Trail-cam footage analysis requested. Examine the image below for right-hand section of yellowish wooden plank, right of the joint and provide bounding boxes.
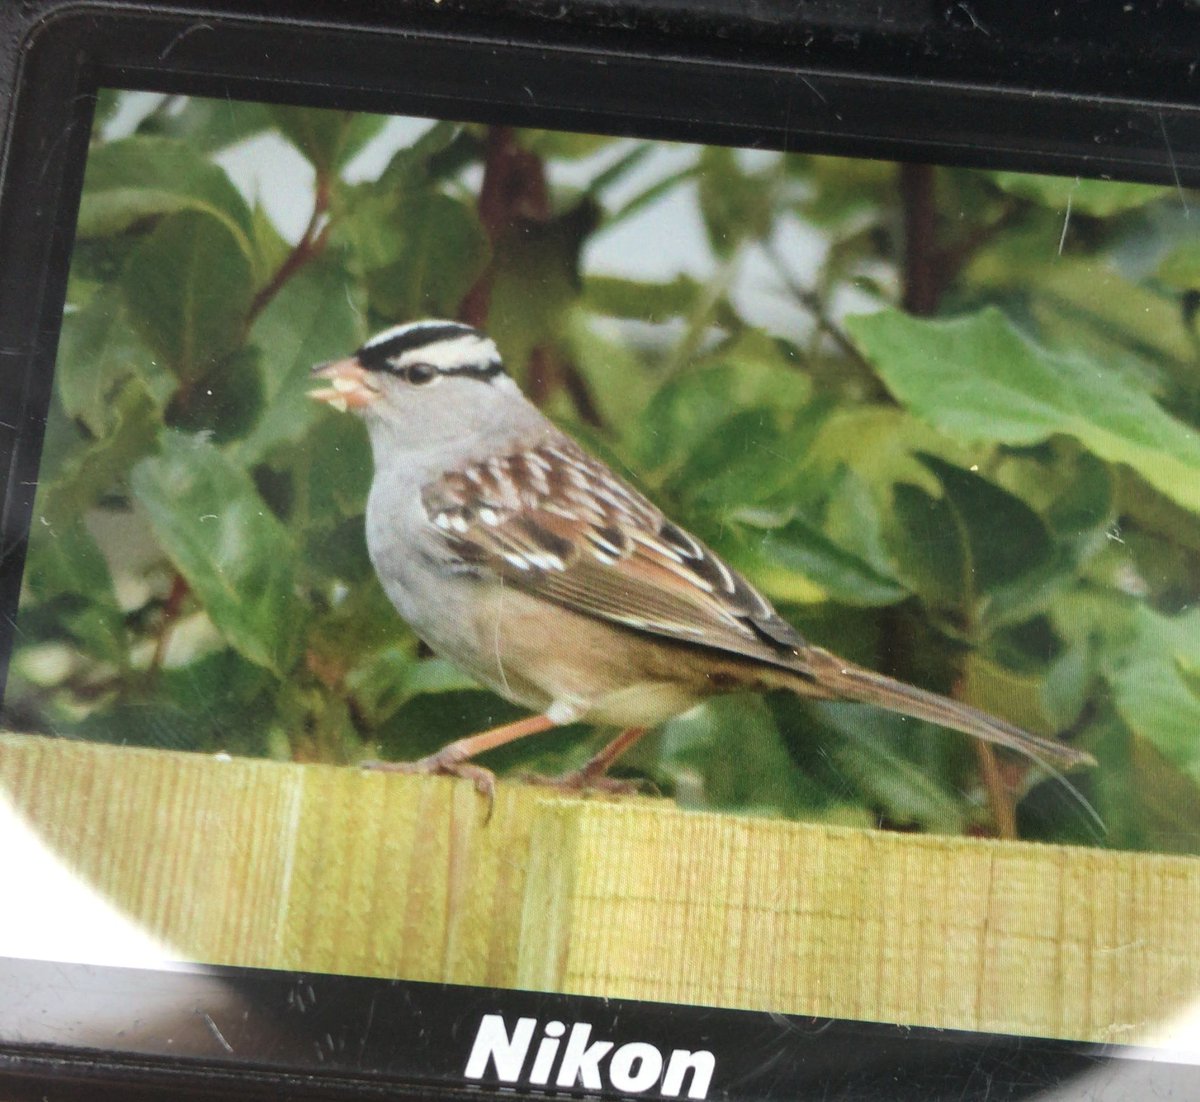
[517,803,1200,1042]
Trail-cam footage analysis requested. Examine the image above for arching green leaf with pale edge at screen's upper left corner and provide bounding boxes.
[76,137,252,257]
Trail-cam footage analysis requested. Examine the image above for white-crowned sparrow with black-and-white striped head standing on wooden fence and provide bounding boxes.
[313,321,1092,792]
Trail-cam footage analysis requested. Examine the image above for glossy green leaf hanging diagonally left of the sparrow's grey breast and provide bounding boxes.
[131,432,305,673]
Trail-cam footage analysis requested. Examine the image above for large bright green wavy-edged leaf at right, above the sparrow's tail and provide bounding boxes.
[846,309,1200,510]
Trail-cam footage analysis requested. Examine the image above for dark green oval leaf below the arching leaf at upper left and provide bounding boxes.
[121,211,254,383]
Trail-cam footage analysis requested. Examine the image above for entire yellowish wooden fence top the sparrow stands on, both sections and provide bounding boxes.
[0,735,1200,1041]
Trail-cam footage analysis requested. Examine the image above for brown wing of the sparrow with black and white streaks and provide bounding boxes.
[422,437,805,669]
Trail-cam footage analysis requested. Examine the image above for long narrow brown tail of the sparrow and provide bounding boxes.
[792,647,1096,768]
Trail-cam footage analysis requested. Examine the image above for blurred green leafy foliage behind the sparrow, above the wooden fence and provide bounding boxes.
[4,95,1200,852]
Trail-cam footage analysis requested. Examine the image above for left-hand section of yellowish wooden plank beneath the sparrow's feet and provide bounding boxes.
[0,735,538,986]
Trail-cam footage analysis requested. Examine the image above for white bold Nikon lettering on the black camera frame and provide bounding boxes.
[464,1014,716,1098]
